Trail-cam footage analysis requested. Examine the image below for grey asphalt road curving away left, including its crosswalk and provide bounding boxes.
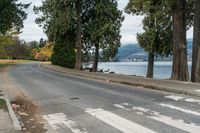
[10,63,200,133]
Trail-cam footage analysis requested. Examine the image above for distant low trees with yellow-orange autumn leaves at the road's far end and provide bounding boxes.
[0,36,53,61]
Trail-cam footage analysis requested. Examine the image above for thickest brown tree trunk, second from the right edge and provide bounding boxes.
[171,0,189,81]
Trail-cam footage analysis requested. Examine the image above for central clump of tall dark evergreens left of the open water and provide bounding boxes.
[34,0,124,72]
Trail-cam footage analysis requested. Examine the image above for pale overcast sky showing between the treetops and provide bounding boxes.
[19,0,192,45]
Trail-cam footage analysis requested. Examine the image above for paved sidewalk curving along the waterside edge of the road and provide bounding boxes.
[41,63,200,99]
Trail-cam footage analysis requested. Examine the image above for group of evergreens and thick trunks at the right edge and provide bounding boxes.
[125,0,200,82]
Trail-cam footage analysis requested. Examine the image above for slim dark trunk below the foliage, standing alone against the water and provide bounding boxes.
[146,53,154,78]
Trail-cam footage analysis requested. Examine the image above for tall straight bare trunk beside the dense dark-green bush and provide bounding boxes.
[75,0,82,70]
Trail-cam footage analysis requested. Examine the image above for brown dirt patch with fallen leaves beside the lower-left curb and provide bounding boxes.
[11,96,47,133]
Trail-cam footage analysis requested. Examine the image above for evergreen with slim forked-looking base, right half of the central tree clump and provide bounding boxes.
[87,0,123,72]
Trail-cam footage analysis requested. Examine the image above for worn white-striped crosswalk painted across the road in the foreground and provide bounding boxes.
[44,95,200,133]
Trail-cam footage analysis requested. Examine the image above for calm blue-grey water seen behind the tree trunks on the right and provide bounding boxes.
[98,62,191,79]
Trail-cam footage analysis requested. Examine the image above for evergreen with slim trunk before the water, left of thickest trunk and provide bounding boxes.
[126,0,172,78]
